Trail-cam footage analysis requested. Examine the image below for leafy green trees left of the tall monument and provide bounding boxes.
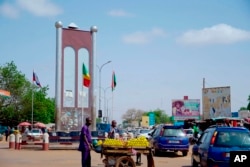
[0,61,55,126]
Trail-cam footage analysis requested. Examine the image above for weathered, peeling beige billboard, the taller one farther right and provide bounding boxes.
[202,86,232,119]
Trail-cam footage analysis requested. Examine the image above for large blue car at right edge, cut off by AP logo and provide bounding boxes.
[191,125,250,167]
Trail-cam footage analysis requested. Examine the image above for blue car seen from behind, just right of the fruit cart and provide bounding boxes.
[149,124,189,156]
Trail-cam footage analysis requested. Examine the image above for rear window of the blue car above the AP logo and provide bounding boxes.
[214,131,250,147]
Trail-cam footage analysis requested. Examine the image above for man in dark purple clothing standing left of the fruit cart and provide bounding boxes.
[78,117,92,167]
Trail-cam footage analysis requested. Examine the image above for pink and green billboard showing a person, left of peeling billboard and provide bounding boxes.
[172,99,200,120]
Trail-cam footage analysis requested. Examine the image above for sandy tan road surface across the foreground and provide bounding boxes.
[0,141,190,167]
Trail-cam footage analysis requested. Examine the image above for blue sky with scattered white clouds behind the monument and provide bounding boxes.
[0,0,250,121]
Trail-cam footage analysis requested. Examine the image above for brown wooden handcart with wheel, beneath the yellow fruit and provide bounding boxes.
[101,146,155,167]
